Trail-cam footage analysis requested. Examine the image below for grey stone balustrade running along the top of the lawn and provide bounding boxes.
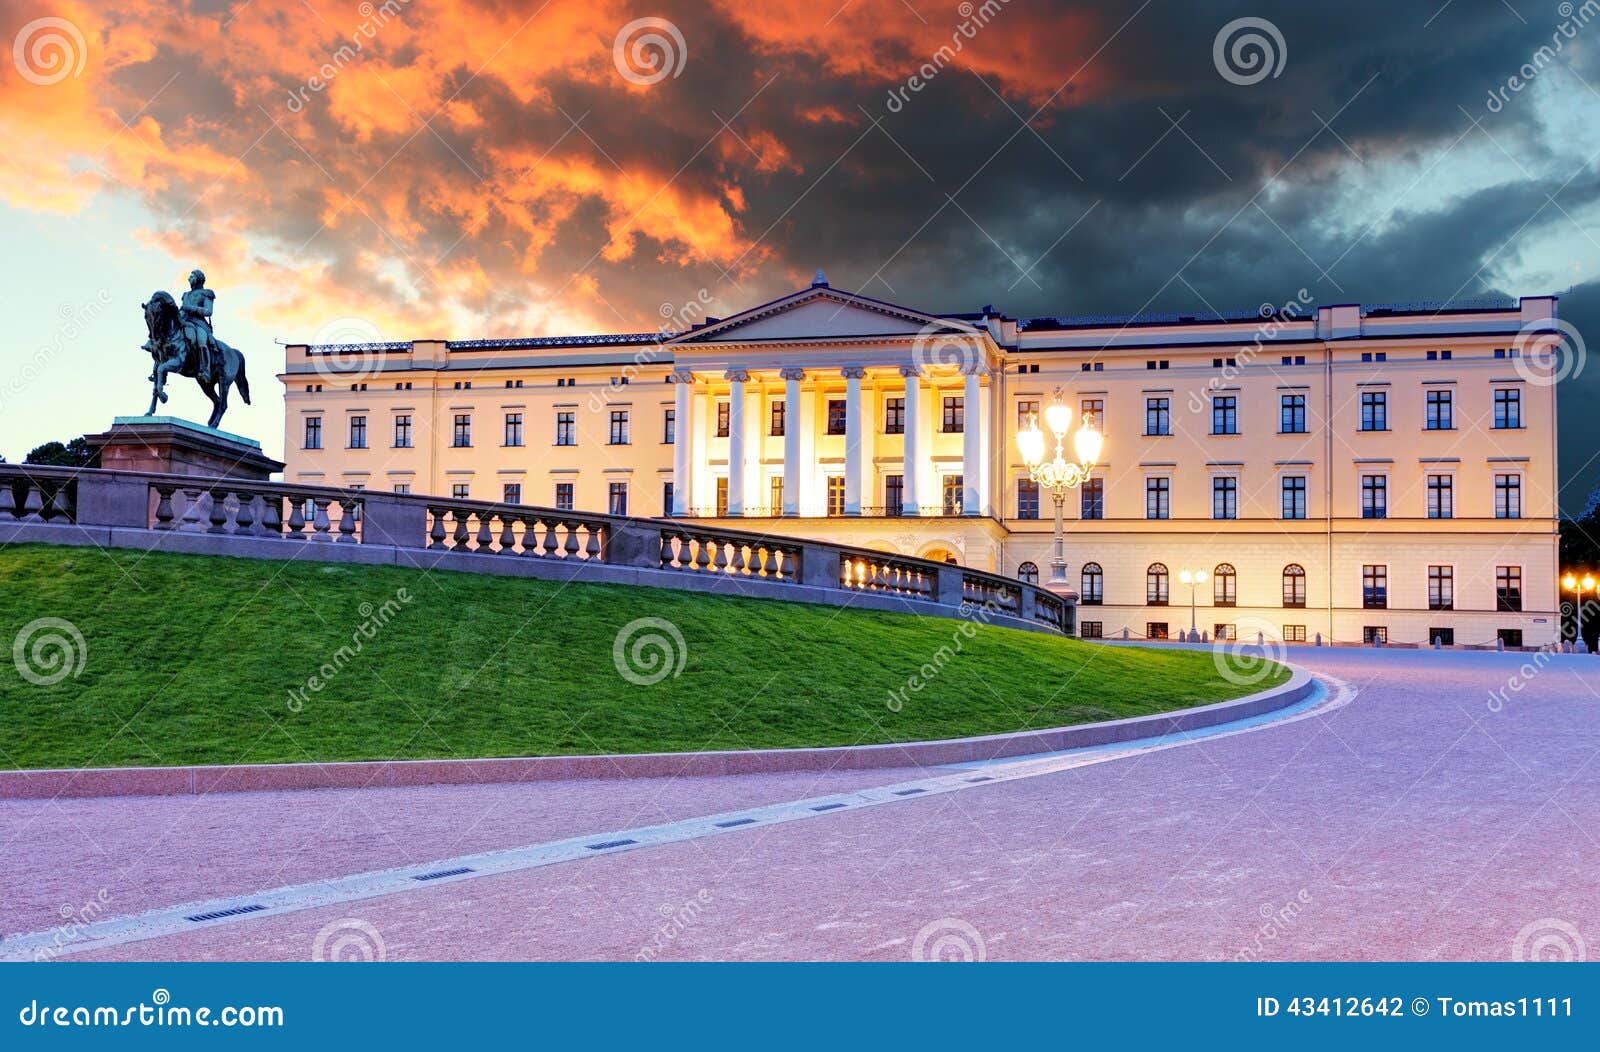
[0,464,1074,633]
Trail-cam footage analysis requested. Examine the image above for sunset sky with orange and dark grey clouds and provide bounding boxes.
[0,0,1600,510]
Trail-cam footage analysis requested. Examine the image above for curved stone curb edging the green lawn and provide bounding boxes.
[0,670,1317,799]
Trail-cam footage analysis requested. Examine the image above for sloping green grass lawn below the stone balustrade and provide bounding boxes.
[0,545,1288,767]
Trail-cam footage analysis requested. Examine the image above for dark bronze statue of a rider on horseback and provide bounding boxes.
[144,270,250,427]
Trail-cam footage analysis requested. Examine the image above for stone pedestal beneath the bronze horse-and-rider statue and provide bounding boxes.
[86,416,283,483]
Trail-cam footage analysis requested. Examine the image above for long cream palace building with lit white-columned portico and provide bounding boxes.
[280,272,1560,646]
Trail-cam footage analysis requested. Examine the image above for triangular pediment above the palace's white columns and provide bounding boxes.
[670,286,979,344]
